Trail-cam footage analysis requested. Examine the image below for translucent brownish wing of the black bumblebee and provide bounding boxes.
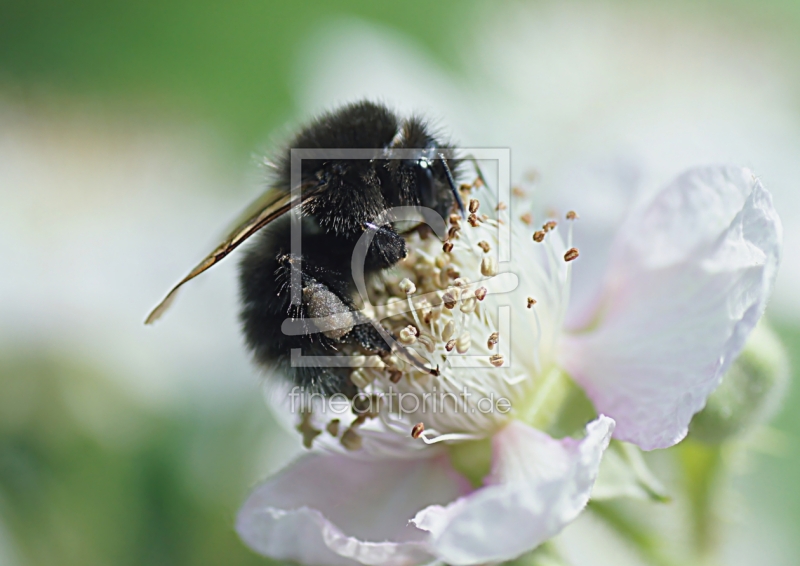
[144,187,317,324]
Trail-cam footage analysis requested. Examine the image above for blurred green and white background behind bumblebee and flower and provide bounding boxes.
[0,0,800,566]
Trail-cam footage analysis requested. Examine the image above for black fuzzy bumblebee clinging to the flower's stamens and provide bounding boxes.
[146,102,463,394]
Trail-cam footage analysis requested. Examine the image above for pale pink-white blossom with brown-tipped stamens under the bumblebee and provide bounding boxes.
[237,163,781,565]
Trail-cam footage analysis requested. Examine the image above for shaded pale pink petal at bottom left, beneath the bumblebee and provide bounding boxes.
[236,454,463,566]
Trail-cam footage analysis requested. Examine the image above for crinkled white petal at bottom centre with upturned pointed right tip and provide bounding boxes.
[413,416,614,565]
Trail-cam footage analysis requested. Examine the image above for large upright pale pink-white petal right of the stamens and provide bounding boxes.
[561,167,782,450]
